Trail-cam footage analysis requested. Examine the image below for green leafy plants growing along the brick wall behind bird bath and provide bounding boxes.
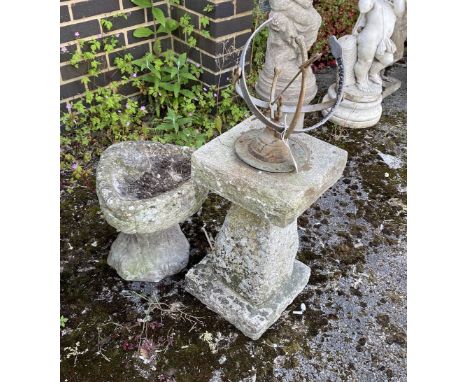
[61,0,247,192]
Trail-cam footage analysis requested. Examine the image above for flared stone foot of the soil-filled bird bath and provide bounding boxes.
[107,224,190,282]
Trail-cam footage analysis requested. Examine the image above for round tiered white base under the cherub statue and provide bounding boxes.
[322,84,383,129]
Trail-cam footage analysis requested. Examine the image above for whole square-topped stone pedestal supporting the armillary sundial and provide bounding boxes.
[185,118,347,340]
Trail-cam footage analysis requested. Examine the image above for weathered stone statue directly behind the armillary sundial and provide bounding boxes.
[255,0,322,110]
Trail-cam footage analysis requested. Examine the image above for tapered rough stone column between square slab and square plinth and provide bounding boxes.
[214,205,299,305]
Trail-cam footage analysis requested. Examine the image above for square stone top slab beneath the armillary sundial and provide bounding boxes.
[192,117,348,227]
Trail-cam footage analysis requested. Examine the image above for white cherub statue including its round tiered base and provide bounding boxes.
[324,0,406,128]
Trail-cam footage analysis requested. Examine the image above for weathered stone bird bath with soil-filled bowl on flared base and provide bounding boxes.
[96,141,207,282]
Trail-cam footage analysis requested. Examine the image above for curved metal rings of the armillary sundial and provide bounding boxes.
[236,18,344,134]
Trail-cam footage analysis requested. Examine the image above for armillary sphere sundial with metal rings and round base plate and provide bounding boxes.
[235,18,344,173]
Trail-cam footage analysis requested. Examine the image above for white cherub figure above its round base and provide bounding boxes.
[353,0,406,92]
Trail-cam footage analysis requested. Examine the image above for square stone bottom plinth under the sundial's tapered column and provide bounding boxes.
[185,255,310,340]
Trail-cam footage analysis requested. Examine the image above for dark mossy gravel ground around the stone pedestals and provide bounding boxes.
[61,64,406,382]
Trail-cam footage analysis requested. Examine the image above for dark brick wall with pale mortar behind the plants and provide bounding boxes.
[60,0,253,108]
